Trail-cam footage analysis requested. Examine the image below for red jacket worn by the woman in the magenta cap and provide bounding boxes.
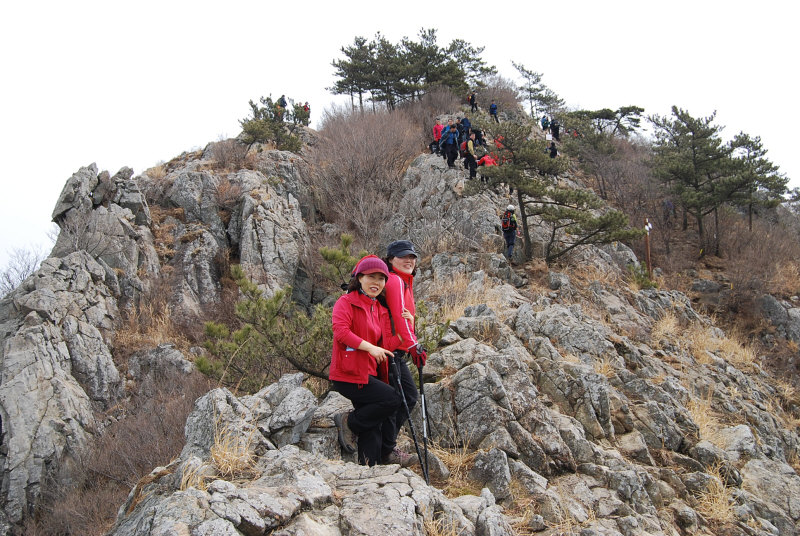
[328,292,399,385]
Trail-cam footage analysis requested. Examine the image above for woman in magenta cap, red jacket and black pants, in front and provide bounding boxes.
[328,255,402,465]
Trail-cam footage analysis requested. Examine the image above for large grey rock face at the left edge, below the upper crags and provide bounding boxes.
[0,251,122,522]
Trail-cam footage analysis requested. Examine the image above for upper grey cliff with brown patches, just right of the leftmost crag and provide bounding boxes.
[138,151,309,310]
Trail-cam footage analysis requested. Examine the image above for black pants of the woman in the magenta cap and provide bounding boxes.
[333,369,400,465]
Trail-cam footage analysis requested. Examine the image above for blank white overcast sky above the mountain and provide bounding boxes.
[0,0,800,268]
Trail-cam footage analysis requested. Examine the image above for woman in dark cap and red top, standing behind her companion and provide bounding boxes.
[385,240,428,464]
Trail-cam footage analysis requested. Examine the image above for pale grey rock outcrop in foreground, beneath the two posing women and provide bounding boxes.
[110,374,514,536]
